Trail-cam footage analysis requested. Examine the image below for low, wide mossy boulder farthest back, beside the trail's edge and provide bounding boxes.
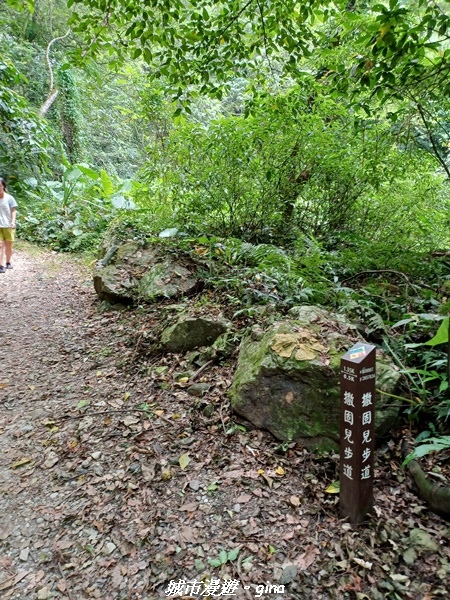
[94,241,199,302]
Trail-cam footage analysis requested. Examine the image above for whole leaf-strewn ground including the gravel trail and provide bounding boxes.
[0,245,450,600]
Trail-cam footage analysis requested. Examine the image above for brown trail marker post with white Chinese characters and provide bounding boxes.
[339,343,376,524]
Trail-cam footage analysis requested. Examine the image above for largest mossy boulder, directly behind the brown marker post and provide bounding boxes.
[231,306,400,451]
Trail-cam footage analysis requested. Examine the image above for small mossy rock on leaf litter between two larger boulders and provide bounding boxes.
[161,315,230,352]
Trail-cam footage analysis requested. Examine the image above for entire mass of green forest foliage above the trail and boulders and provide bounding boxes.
[0,0,450,442]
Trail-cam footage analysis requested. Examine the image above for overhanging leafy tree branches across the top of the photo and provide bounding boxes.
[69,0,450,105]
